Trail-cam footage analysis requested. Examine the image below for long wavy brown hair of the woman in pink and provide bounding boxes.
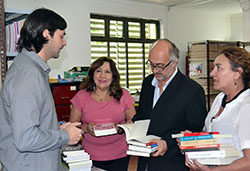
[80,57,123,102]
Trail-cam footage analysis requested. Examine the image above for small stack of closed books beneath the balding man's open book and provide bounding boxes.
[127,142,158,157]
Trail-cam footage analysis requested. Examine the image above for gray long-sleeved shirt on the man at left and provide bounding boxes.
[0,49,69,171]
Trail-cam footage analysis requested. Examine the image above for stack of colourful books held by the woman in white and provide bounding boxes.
[172,132,240,165]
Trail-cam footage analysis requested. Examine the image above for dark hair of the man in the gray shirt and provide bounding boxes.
[17,8,67,53]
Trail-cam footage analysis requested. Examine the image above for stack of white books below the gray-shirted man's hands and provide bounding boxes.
[62,146,92,171]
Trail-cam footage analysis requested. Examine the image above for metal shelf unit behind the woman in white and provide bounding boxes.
[186,40,242,110]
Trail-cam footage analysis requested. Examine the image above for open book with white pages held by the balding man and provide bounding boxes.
[117,119,161,146]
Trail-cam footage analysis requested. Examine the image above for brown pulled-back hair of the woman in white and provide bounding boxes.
[220,47,250,88]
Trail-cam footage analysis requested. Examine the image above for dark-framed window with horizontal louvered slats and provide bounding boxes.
[90,14,160,93]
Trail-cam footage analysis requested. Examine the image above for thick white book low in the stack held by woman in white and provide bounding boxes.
[185,148,240,159]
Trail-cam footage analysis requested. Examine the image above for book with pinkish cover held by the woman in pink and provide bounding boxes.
[94,123,117,137]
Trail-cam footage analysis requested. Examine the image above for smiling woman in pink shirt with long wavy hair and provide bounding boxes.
[70,57,136,171]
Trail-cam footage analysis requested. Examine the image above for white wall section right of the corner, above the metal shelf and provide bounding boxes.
[168,8,240,73]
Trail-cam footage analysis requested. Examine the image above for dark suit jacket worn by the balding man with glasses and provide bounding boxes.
[133,71,207,171]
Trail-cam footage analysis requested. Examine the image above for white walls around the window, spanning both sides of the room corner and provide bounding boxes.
[5,0,242,78]
